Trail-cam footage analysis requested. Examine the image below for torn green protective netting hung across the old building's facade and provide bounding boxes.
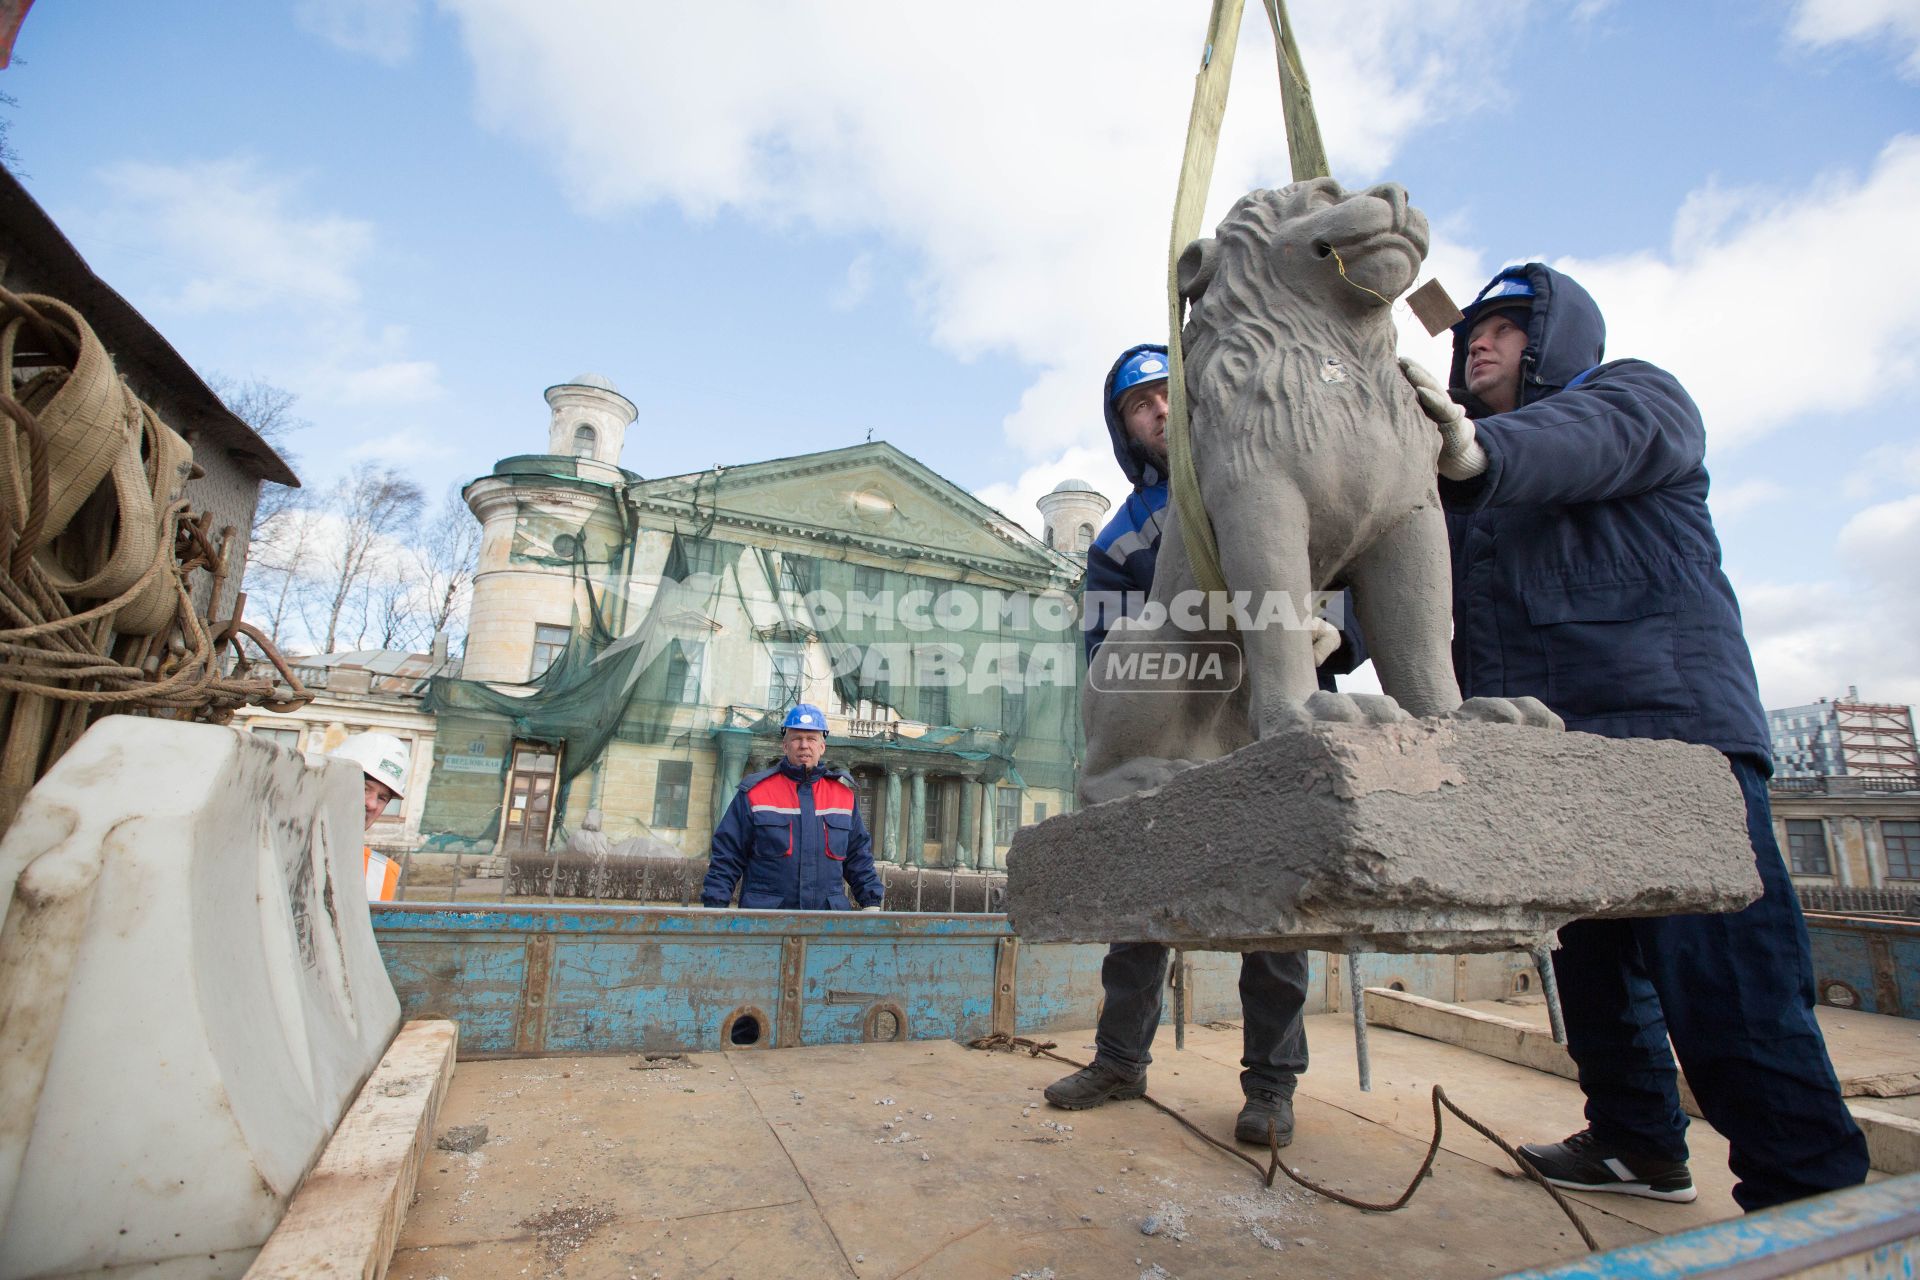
[422,509,1083,846]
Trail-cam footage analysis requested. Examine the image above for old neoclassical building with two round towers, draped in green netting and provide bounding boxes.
[420,374,1106,867]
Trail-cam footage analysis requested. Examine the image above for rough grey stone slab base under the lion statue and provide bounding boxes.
[1008,720,1759,952]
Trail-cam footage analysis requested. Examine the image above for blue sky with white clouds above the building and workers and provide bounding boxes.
[0,0,1920,704]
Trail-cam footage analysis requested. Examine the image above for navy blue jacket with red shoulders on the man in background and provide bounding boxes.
[701,760,887,912]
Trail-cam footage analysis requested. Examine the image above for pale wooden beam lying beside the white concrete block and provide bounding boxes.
[246,1021,459,1280]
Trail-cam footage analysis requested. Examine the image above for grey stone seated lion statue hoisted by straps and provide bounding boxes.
[1081,178,1557,802]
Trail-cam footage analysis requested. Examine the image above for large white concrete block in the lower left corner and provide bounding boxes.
[0,716,399,1280]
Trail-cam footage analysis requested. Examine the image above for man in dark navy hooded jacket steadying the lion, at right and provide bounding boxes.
[1407,263,1866,1211]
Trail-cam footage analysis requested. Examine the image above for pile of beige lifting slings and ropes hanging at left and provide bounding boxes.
[0,290,305,825]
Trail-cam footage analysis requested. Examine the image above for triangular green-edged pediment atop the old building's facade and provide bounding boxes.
[634,443,1077,578]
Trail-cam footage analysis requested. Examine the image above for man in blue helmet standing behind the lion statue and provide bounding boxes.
[1046,344,1365,1146]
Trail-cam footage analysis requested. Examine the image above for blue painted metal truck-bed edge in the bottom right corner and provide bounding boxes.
[1505,1173,1920,1280]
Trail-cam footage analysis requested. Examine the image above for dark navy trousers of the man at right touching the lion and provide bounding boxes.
[1553,756,1866,1211]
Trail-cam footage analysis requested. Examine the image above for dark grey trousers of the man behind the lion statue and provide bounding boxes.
[1094,942,1308,1096]
